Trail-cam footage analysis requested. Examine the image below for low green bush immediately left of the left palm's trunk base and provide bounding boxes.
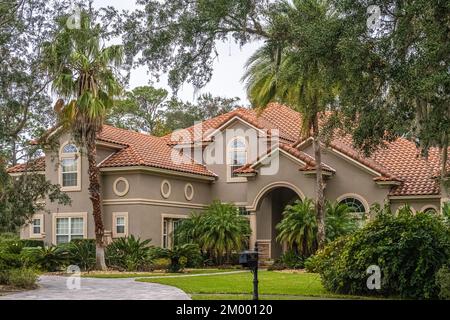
[66,239,95,270]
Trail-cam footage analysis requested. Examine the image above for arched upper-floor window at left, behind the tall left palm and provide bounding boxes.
[60,143,81,191]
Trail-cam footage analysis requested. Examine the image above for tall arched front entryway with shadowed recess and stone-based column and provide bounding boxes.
[255,184,304,259]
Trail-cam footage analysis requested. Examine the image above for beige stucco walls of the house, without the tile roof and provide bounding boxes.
[21,120,441,258]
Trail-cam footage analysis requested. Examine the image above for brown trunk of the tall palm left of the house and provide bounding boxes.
[87,140,106,270]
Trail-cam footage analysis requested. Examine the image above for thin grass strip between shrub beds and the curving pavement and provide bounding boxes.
[83,269,241,279]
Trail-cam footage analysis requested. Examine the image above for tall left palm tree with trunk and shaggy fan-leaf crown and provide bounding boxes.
[43,12,123,270]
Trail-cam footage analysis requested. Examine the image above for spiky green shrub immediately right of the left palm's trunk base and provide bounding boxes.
[106,235,152,271]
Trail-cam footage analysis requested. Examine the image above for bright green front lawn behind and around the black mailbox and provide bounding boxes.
[136,271,376,300]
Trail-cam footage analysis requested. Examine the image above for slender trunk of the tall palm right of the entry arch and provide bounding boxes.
[312,114,325,249]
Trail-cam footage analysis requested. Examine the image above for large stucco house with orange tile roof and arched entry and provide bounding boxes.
[9,104,448,258]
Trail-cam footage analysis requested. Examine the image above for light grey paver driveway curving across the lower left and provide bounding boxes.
[0,276,190,300]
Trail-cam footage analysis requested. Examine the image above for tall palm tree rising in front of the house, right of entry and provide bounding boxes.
[242,0,339,248]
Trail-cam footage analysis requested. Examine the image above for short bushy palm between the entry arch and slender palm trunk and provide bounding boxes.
[276,199,317,256]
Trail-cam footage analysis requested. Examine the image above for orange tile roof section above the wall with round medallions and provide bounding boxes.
[99,125,216,177]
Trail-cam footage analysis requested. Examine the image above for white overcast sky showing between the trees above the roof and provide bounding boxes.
[94,0,260,105]
